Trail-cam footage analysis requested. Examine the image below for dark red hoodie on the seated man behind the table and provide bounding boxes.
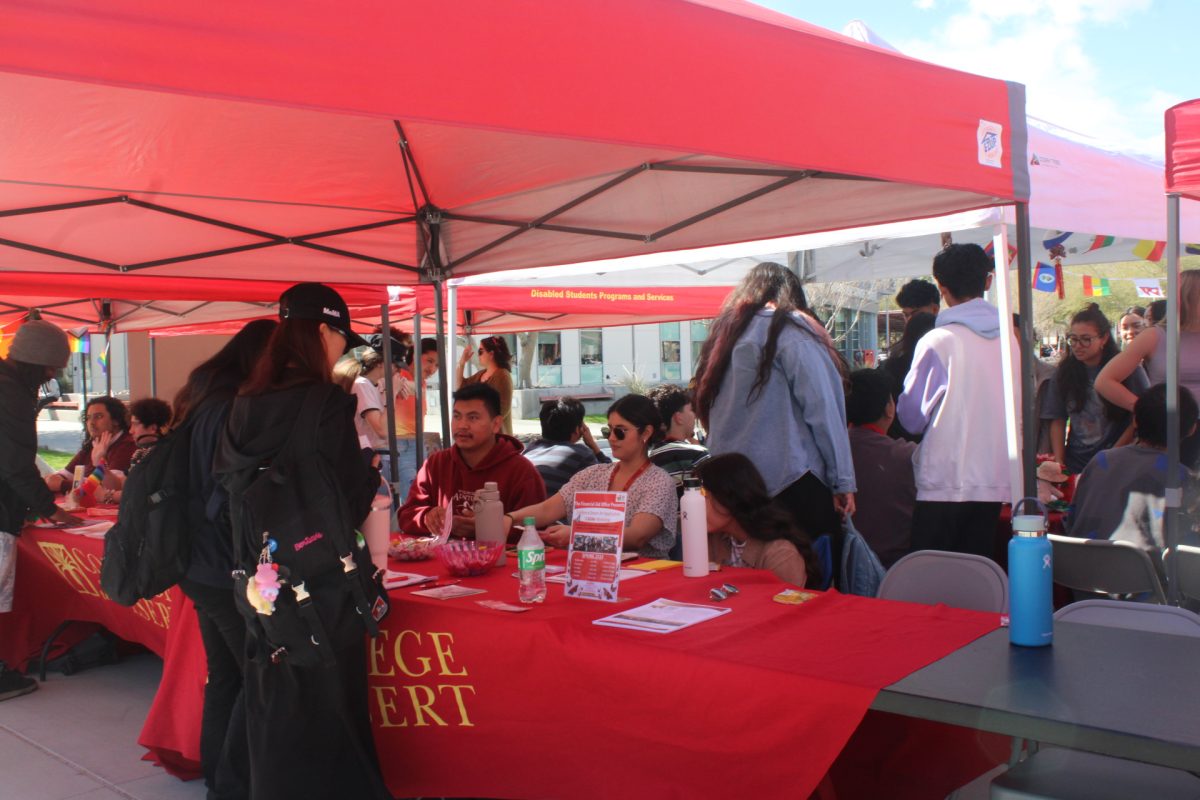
[400,433,546,536]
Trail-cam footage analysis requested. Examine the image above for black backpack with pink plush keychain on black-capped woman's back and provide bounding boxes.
[230,384,388,667]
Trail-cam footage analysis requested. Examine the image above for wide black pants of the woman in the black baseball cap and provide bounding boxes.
[246,578,391,800]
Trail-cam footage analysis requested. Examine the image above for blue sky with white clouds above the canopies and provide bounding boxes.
[757,0,1200,161]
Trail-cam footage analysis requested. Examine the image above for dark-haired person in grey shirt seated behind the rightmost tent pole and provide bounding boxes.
[1063,384,1198,561]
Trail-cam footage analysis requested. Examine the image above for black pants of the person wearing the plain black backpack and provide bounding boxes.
[180,578,250,800]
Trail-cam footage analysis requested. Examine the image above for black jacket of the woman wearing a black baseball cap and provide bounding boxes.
[212,384,379,568]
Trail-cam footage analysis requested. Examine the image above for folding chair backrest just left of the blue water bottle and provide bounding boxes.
[876,551,1008,614]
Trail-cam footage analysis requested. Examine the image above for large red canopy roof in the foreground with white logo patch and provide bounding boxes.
[0,0,1028,284]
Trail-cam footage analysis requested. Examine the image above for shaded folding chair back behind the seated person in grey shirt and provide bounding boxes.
[1049,534,1166,603]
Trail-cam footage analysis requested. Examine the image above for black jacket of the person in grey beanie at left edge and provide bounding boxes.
[0,359,55,536]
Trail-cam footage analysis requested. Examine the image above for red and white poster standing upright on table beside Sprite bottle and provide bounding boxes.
[565,492,629,603]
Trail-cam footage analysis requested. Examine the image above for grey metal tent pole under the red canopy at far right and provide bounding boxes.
[1163,194,1183,604]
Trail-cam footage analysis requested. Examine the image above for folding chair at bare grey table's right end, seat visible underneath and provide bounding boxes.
[991,604,1200,800]
